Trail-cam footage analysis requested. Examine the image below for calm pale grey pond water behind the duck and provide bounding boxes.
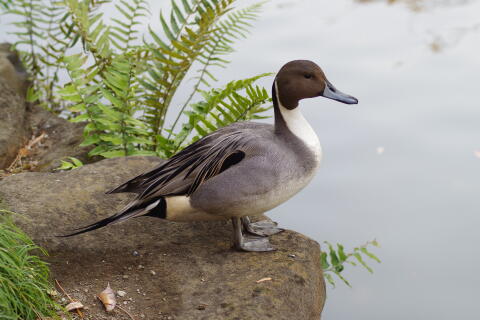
[0,0,480,320]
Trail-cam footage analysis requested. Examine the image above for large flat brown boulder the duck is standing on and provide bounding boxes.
[0,157,325,320]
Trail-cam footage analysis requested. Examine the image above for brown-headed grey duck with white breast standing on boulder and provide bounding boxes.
[62,60,358,252]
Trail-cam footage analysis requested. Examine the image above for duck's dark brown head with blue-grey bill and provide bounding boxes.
[274,60,358,110]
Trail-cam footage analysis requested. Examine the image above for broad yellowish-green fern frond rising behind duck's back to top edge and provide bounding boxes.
[142,0,240,149]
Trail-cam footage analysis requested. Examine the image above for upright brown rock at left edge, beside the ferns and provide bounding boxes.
[0,43,27,169]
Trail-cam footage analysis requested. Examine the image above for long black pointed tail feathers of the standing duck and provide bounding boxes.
[56,198,166,238]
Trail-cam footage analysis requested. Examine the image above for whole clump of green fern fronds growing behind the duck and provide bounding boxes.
[3,0,268,157]
